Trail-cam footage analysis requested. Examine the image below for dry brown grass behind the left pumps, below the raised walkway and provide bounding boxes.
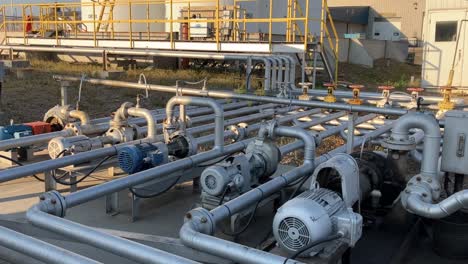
[2,60,242,123]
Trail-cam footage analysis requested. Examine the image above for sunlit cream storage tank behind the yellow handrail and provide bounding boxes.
[81,0,166,32]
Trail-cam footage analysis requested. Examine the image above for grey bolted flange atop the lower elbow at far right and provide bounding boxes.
[401,175,441,208]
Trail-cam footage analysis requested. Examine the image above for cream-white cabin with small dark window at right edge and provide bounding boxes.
[422,0,468,88]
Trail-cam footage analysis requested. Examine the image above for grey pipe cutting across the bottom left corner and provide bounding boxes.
[0,226,101,264]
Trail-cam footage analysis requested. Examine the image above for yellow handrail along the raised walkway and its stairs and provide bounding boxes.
[0,0,339,79]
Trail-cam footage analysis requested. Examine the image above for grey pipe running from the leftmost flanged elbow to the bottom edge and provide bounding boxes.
[26,204,198,264]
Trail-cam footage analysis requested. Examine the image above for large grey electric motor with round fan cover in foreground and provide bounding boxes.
[273,189,362,256]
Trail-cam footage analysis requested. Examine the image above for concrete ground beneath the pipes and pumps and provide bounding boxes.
[0,159,467,264]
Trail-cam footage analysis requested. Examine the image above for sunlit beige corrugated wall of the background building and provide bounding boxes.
[328,0,424,39]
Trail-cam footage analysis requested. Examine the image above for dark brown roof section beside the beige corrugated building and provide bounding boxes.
[330,6,370,25]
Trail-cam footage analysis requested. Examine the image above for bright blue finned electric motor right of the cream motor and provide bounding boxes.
[117,143,165,174]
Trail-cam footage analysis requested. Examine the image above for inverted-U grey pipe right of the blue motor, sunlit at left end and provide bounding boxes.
[166,96,224,151]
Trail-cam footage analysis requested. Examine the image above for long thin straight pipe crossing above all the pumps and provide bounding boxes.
[55,76,408,116]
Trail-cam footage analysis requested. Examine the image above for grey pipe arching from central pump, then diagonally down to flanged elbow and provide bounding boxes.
[179,122,316,264]
